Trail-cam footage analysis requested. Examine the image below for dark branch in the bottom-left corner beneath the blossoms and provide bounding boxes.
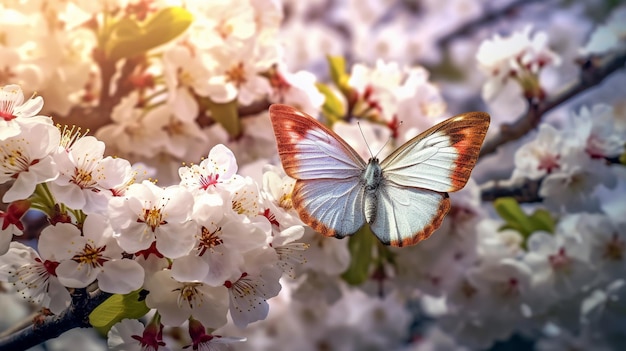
[0,289,111,350]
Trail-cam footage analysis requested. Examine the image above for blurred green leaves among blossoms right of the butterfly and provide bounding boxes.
[493,197,556,242]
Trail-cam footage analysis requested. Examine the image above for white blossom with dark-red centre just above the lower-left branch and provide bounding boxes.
[50,214,144,294]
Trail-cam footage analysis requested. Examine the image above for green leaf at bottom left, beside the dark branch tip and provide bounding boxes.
[89,289,150,335]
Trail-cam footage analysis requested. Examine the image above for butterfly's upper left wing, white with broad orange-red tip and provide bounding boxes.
[270,105,365,179]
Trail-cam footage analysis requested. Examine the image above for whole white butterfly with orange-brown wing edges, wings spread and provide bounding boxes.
[269,104,490,247]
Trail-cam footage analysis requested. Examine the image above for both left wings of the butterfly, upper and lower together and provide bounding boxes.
[270,104,365,238]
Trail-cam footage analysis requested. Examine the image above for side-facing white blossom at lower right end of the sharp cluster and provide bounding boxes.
[224,267,282,329]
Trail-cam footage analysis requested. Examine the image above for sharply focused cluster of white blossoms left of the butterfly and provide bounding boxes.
[0,85,306,350]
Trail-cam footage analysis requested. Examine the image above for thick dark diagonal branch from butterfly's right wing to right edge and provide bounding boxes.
[480,49,626,157]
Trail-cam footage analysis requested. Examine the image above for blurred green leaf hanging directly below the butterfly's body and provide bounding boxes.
[341,224,376,285]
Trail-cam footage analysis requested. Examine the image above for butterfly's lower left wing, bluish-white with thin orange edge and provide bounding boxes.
[291,177,365,238]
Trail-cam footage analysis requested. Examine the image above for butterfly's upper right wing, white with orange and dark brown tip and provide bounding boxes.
[381,112,490,192]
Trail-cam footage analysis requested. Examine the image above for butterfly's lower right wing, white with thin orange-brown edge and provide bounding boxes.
[370,182,450,246]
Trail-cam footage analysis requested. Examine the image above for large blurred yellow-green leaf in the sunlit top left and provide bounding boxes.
[105,7,193,61]
